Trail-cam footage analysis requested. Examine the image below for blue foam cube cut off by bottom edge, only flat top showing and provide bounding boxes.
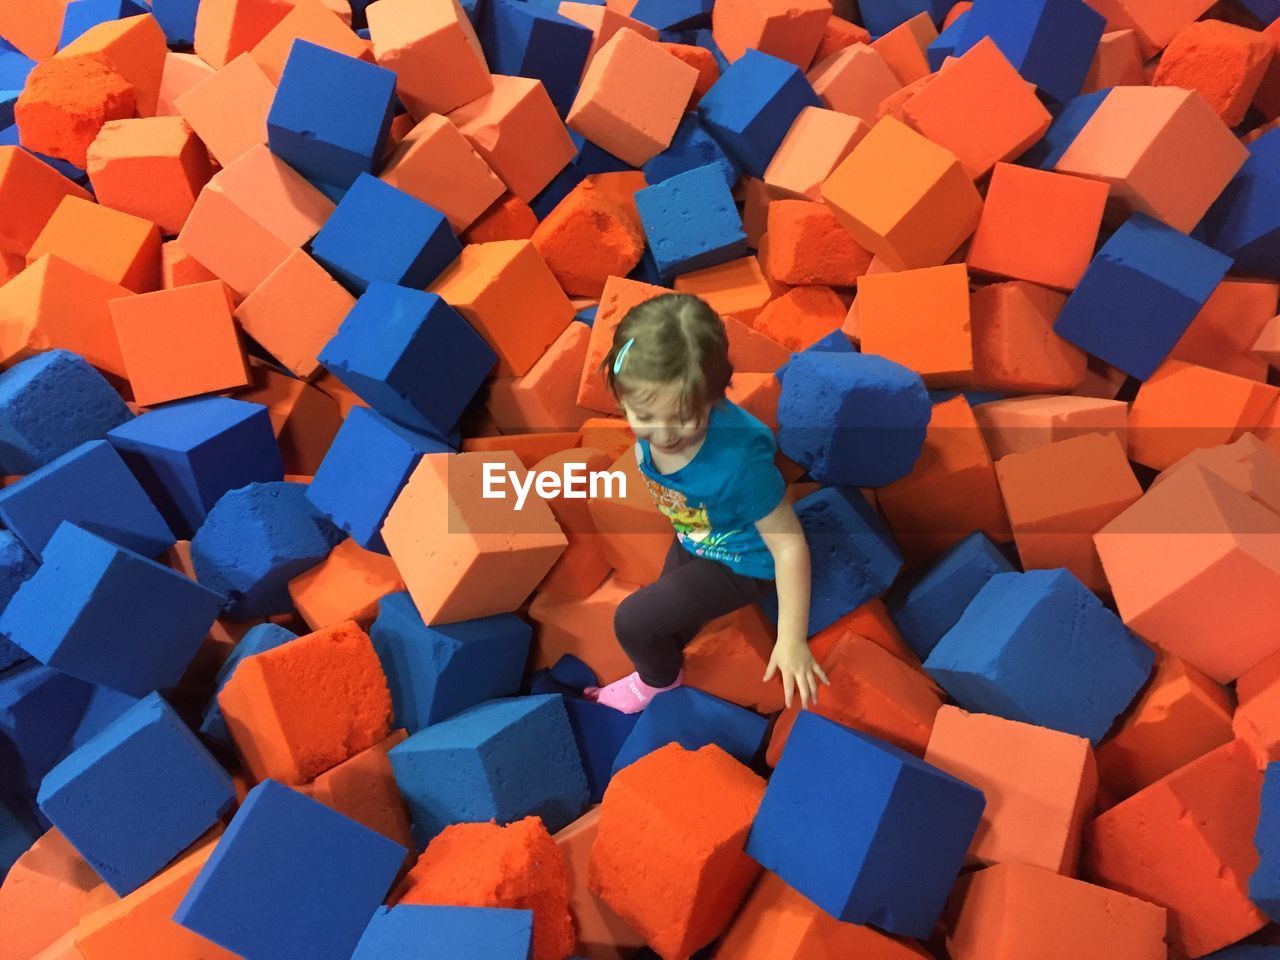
[351,904,534,960]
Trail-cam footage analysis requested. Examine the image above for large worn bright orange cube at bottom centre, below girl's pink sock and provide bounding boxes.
[588,744,764,957]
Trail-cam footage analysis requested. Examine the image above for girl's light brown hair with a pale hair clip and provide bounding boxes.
[600,293,733,419]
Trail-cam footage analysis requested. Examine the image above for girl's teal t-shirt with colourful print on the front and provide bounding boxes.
[636,399,786,580]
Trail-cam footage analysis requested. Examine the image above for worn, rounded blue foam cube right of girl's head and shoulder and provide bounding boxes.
[778,349,933,486]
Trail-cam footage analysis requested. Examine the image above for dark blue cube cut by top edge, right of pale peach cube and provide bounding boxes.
[479,0,591,116]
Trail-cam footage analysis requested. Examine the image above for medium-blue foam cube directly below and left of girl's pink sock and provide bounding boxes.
[387,695,589,846]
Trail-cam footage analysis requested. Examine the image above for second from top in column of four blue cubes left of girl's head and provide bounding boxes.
[311,173,462,294]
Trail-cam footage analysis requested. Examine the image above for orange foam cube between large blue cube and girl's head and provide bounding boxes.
[429,241,573,376]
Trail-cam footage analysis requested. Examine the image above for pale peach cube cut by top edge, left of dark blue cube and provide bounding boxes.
[366,0,494,118]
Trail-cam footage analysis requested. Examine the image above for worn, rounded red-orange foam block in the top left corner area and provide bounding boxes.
[13,56,137,169]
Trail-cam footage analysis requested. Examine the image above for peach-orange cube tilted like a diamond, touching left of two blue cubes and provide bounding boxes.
[236,250,356,380]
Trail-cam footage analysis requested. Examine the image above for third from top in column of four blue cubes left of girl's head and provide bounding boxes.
[320,283,498,435]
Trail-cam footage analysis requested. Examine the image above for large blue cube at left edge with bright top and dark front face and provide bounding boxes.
[0,522,220,696]
